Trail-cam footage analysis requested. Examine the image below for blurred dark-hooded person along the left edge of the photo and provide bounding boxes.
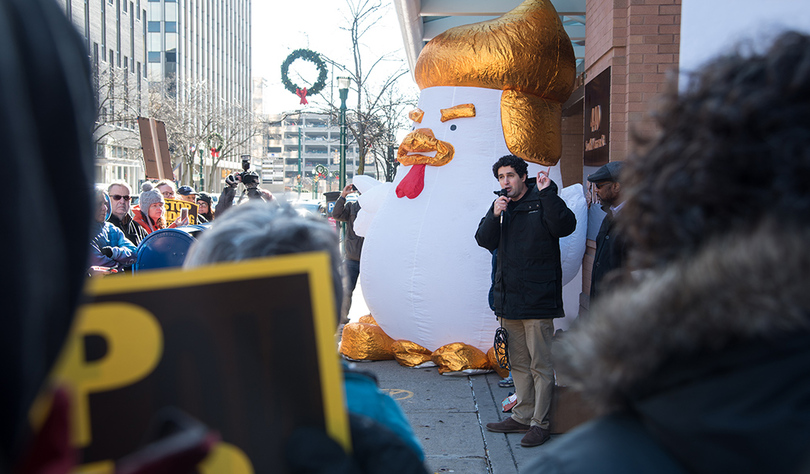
[0,0,96,473]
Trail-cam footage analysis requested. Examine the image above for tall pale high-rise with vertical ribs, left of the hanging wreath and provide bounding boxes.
[142,0,255,191]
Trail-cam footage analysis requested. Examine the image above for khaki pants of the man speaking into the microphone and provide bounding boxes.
[500,318,554,430]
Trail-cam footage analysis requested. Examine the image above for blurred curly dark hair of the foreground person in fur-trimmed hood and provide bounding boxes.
[619,32,810,267]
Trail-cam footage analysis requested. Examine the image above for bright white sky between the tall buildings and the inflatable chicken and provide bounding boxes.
[252,0,417,113]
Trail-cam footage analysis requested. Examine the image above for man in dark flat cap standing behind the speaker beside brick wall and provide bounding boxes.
[588,161,627,301]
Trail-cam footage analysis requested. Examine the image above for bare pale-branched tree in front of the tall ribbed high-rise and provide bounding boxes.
[150,79,261,189]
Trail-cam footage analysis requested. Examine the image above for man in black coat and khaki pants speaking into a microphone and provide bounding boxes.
[475,155,577,447]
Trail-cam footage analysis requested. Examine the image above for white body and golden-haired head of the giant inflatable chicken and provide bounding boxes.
[346,0,585,358]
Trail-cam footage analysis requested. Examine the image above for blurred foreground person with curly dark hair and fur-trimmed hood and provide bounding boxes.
[528,32,810,473]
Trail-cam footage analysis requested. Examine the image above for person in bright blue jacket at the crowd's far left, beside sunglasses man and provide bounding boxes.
[90,189,138,271]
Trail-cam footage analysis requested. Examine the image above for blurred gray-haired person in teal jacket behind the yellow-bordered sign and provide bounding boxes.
[183,200,426,473]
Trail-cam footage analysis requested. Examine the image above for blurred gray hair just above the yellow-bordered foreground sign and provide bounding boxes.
[183,200,343,314]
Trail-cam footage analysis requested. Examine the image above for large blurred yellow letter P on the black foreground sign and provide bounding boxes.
[54,303,163,447]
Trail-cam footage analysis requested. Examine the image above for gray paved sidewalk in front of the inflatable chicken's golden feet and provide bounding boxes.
[349,285,565,474]
